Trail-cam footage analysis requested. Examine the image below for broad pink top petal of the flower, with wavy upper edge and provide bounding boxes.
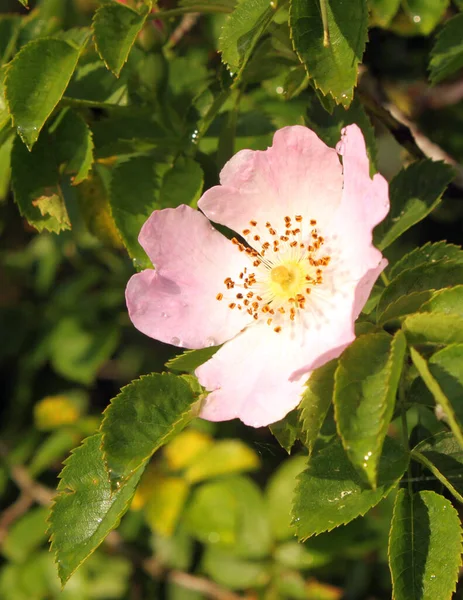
[198,126,342,243]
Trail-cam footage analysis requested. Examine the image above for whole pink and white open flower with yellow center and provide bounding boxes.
[126,125,389,427]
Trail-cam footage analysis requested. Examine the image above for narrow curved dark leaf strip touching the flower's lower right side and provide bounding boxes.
[377,255,463,323]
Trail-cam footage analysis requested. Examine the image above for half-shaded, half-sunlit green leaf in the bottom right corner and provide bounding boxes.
[389,489,462,600]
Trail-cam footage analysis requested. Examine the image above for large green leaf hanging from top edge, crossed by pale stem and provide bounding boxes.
[290,0,368,107]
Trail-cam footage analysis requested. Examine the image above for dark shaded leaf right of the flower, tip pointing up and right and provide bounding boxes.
[374,159,454,250]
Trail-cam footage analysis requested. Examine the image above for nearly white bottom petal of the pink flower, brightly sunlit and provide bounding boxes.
[196,314,354,427]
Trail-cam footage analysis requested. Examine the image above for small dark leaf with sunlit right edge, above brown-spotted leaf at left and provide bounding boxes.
[50,109,93,185]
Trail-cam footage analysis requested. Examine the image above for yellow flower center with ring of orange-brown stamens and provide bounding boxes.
[216,215,331,333]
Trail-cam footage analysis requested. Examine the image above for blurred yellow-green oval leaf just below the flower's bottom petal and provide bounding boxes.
[184,440,260,483]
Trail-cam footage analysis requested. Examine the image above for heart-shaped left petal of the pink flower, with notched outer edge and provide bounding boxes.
[126,205,252,348]
